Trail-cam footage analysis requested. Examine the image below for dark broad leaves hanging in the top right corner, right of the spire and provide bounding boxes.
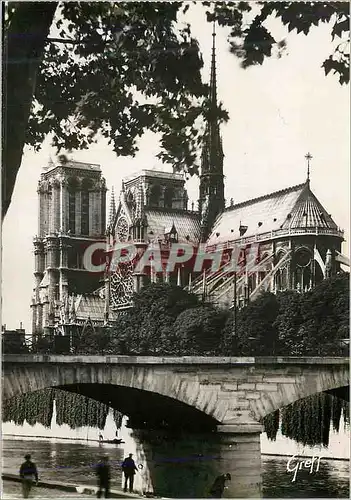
[205,2,350,84]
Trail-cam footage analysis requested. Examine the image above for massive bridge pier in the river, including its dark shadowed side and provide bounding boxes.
[128,423,262,498]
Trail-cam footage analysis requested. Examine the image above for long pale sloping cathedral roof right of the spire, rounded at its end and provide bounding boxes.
[207,182,339,245]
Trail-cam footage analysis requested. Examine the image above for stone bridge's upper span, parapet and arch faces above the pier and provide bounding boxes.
[3,355,349,425]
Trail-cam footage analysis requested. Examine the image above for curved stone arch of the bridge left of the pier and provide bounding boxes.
[3,356,228,427]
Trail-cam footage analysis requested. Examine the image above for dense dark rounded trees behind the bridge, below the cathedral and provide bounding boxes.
[105,273,349,356]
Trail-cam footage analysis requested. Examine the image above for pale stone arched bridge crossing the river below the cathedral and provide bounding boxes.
[2,354,349,497]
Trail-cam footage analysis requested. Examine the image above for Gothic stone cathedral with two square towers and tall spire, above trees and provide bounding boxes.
[31,28,349,337]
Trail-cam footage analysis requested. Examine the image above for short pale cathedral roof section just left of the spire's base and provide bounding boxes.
[145,208,200,243]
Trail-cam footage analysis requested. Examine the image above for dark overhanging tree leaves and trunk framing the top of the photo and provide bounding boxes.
[3,2,349,216]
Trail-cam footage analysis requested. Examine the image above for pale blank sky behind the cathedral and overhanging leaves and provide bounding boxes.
[2,5,350,332]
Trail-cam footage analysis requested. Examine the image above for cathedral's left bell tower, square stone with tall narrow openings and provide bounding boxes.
[31,155,106,336]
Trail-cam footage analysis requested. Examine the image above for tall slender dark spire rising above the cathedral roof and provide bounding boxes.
[199,23,225,241]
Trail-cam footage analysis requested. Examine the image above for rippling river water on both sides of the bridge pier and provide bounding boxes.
[3,438,349,498]
